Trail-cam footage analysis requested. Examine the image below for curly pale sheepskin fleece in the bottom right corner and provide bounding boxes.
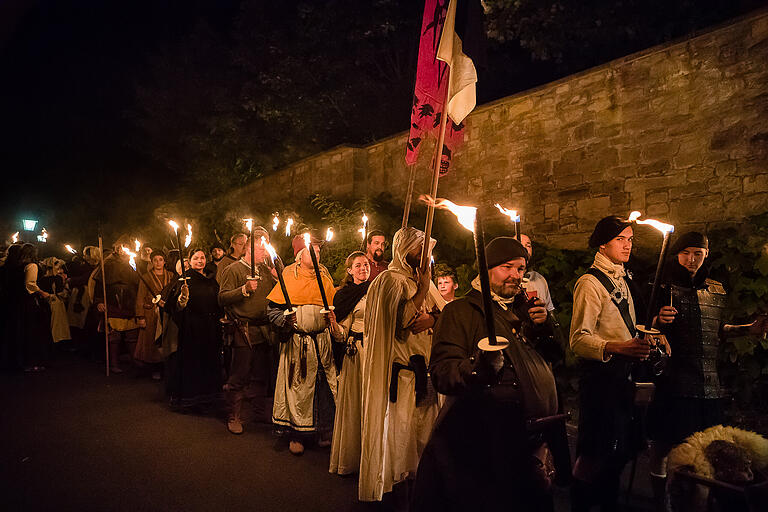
[667,425,768,478]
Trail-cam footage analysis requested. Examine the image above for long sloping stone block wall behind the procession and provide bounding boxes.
[228,10,768,251]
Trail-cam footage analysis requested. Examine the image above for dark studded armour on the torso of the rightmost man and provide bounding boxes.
[668,279,726,398]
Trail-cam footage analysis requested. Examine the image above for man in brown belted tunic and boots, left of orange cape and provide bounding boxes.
[219,226,276,434]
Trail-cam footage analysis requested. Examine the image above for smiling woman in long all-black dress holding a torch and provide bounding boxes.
[165,249,221,411]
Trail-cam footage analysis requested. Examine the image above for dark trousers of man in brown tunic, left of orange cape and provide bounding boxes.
[224,342,272,421]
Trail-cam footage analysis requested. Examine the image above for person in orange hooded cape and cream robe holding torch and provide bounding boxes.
[267,235,342,455]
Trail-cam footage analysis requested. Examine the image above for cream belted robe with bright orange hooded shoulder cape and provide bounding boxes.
[267,260,338,433]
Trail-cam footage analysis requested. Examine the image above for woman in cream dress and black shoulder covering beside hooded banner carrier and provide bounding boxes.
[329,252,371,475]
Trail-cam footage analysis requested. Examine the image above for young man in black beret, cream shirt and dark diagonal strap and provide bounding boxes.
[570,216,651,512]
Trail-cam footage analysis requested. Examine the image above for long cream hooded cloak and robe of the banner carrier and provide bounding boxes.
[358,228,445,501]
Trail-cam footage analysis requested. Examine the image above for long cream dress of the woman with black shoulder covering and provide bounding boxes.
[329,283,367,475]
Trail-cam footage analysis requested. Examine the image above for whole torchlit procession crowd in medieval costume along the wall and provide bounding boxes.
[0,216,768,512]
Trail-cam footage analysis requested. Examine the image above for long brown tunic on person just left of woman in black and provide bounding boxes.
[133,269,173,363]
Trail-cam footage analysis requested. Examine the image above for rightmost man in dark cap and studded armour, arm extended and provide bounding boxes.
[648,231,768,503]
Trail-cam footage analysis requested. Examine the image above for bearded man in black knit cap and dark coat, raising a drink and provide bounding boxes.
[414,237,568,511]
